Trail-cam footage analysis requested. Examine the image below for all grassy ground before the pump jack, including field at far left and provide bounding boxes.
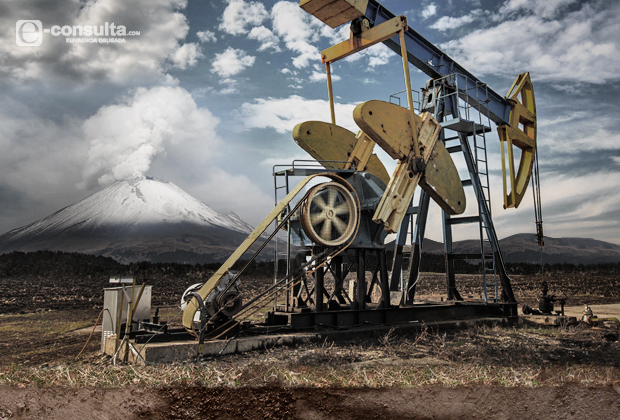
[0,306,620,388]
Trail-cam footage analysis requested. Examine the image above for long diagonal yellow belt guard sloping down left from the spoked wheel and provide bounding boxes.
[183,174,324,334]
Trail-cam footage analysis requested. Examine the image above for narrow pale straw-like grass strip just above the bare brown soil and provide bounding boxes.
[0,363,620,388]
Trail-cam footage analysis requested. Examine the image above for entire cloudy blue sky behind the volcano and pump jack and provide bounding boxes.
[0,0,620,244]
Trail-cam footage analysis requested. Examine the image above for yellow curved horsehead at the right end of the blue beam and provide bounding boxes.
[497,73,536,208]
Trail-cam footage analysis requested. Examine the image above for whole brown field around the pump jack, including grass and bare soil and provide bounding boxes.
[0,273,620,420]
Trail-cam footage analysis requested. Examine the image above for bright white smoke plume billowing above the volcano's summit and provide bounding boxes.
[79,87,219,189]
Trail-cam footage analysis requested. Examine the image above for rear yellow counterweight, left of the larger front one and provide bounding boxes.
[293,121,390,185]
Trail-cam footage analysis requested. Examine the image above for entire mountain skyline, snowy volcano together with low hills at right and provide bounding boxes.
[0,177,620,264]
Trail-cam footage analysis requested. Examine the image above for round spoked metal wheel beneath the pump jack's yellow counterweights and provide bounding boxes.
[300,182,359,246]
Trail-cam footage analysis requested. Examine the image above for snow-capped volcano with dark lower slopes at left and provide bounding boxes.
[0,177,262,263]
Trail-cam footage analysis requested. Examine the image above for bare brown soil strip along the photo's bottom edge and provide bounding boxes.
[0,384,620,420]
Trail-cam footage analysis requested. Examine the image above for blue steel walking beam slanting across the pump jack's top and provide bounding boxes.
[365,0,511,125]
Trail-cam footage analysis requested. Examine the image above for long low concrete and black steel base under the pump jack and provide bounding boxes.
[103,301,519,364]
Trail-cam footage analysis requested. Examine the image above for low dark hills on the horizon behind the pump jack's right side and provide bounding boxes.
[412,233,620,264]
